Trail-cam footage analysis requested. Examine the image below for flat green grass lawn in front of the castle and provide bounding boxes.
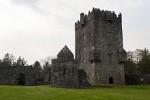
[0,85,150,100]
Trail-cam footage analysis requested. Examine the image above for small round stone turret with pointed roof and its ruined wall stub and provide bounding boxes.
[51,46,90,88]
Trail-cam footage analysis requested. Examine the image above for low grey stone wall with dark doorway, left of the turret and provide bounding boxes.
[0,66,35,85]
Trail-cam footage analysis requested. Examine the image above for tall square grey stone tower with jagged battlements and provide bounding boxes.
[75,8,126,84]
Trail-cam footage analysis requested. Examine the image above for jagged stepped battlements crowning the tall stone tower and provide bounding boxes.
[75,8,122,29]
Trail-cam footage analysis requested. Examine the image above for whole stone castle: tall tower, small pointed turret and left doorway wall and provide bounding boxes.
[0,8,126,88]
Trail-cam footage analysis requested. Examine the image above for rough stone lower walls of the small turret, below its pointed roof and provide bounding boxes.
[51,59,79,88]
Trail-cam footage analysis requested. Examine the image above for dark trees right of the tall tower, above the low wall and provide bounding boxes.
[125,48,150,74]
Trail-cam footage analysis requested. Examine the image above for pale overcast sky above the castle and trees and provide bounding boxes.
[0,0,150,64]
